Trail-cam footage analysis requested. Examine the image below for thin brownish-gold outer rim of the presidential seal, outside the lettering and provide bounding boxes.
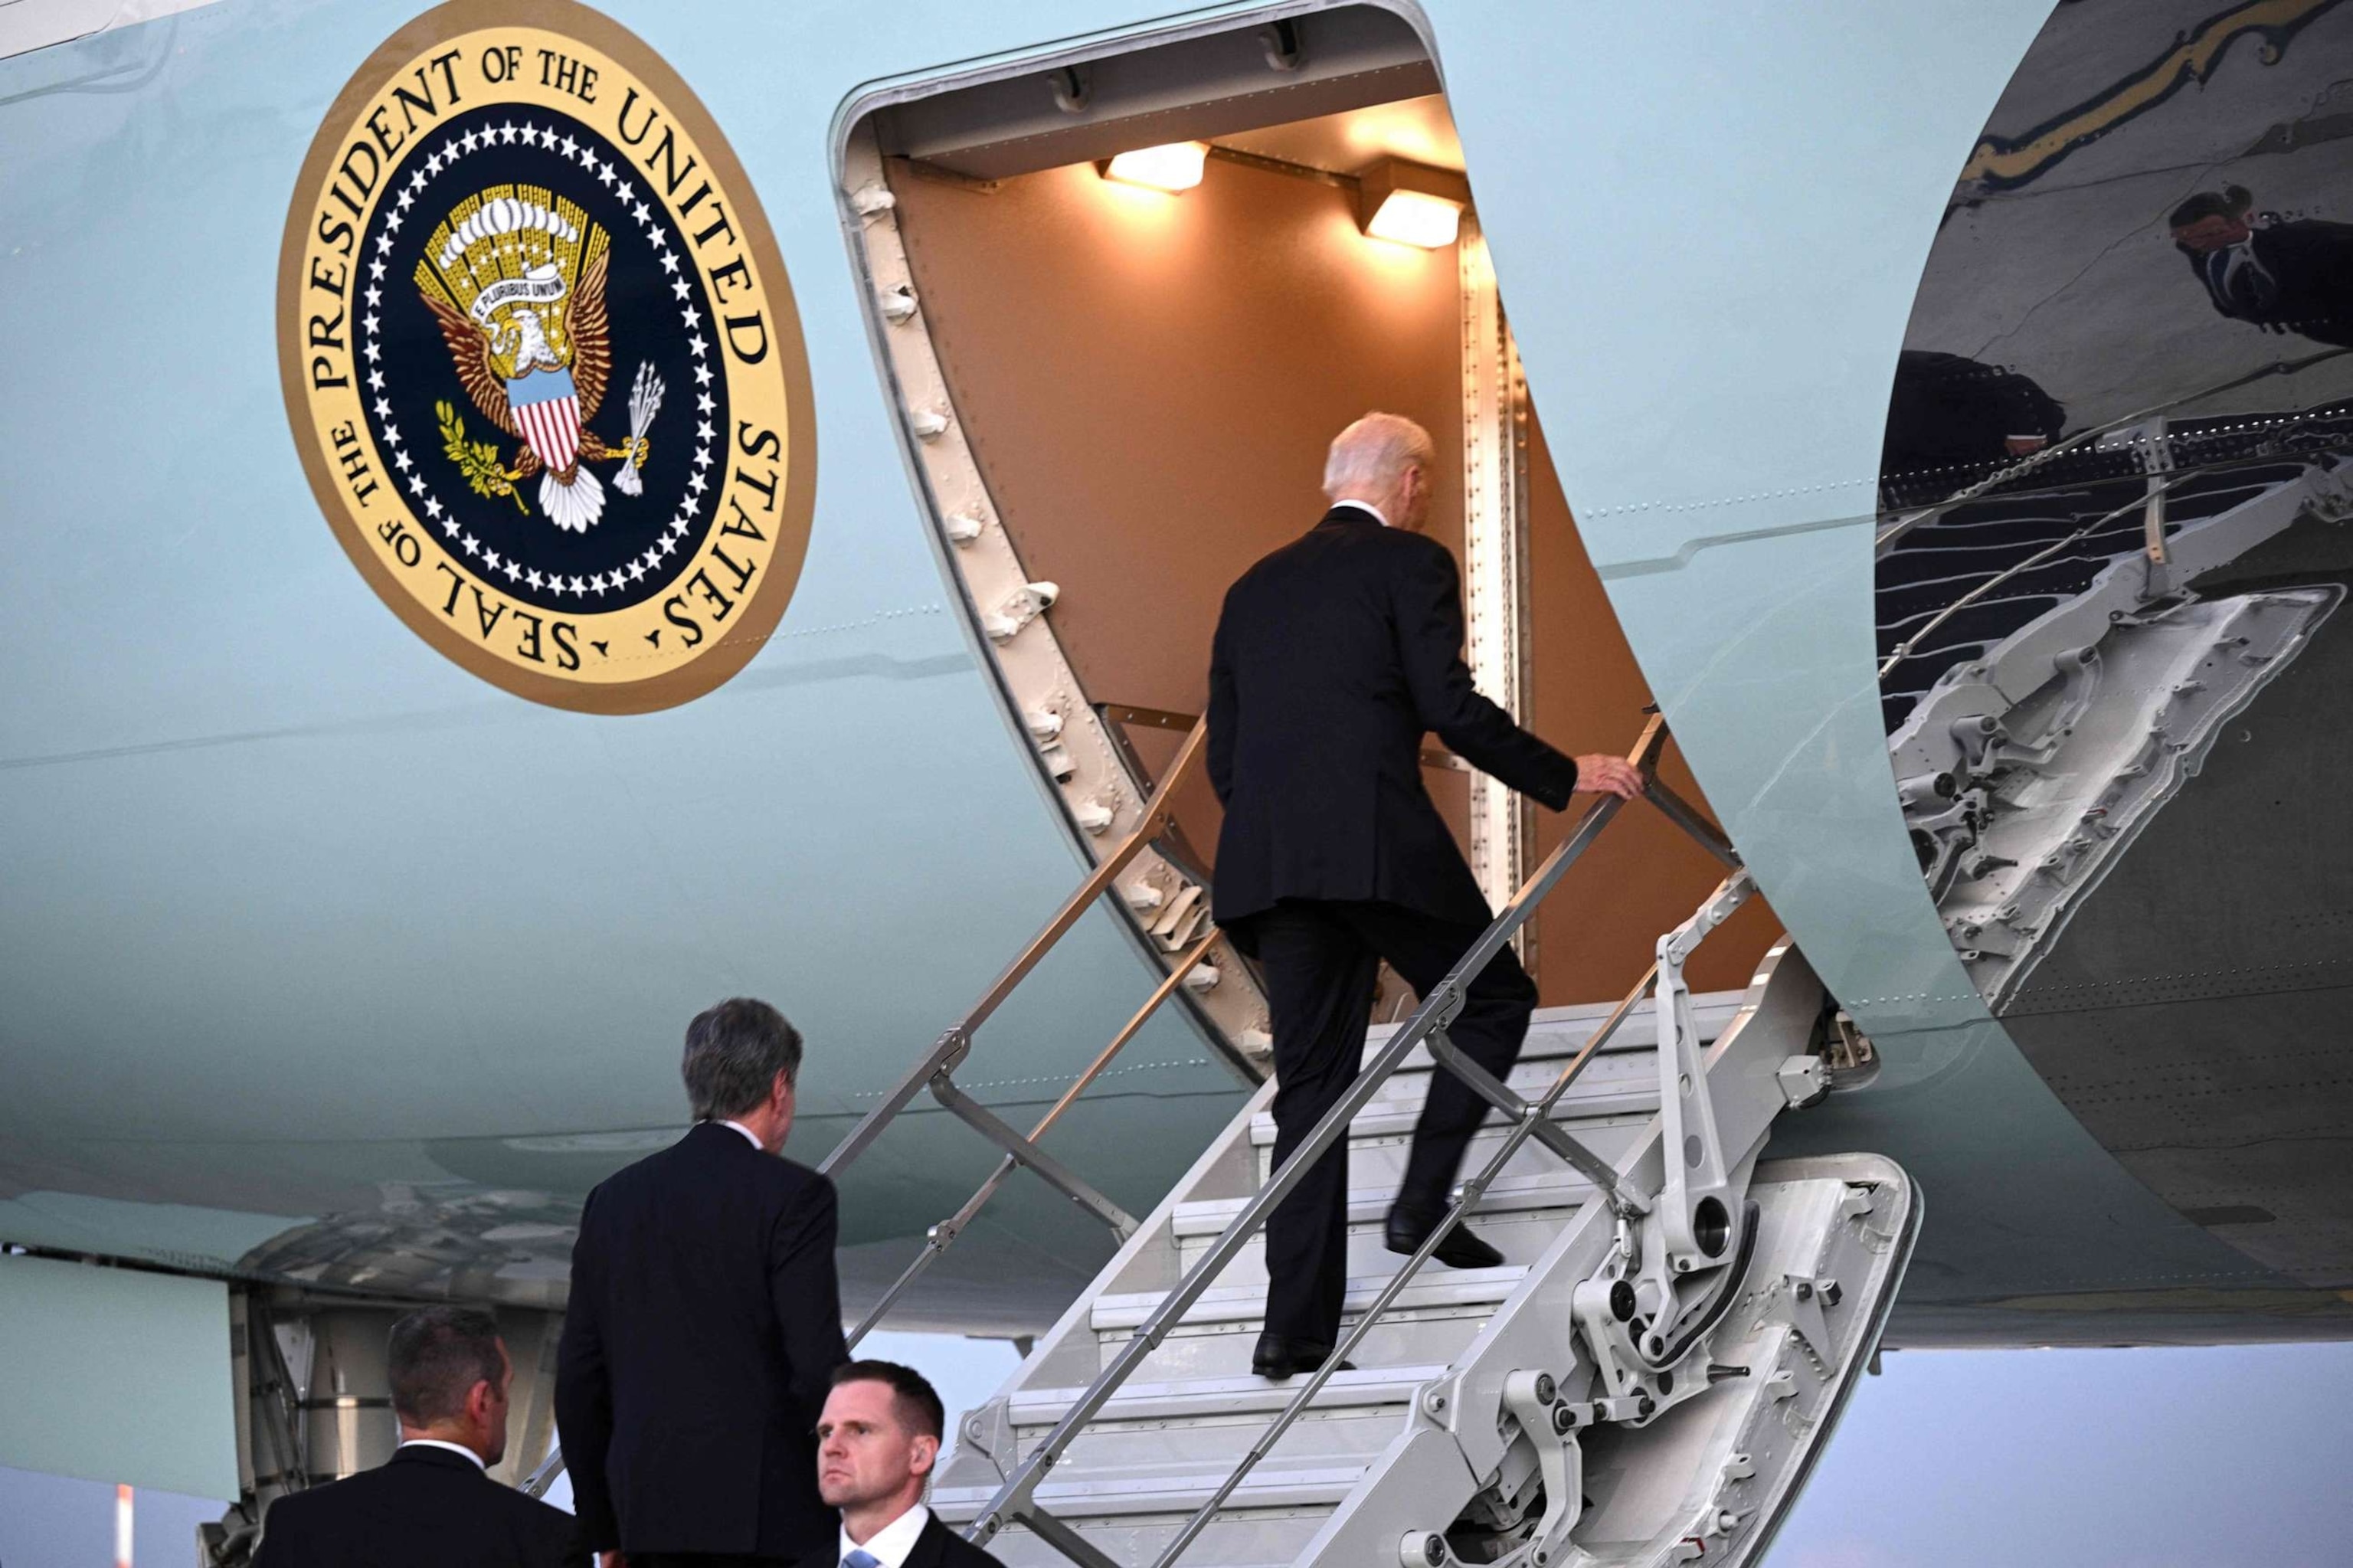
[275,0,817,713]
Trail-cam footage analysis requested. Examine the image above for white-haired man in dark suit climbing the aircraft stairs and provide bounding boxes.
[1209,414,1640,1380]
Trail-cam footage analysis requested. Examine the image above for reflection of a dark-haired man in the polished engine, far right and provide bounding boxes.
[2165,186,2353,346]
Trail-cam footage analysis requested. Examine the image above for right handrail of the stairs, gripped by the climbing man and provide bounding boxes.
[967,713,1743,1568]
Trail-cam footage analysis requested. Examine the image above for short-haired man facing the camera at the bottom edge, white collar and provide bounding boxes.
[803,1361,998,1568]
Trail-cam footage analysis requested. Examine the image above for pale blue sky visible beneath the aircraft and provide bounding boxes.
[0,1335,2353,1568]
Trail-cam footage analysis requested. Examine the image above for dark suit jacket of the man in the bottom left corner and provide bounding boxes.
[254,1448,588,1568]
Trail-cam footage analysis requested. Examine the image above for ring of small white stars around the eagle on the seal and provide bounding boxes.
[360,120,718,598]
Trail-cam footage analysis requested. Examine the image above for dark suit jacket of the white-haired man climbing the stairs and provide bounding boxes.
[1209,506,1576,941]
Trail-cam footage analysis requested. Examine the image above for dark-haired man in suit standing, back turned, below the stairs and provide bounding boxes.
[555,998,847,1568]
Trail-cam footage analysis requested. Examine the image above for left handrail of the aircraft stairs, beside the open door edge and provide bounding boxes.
[522,721,1219,1498]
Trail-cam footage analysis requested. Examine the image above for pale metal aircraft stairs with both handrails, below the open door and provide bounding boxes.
[534,718,1920,1568]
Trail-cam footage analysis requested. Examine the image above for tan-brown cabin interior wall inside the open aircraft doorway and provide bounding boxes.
[892,140,1774,1003]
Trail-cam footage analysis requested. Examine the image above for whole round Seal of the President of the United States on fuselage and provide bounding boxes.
[277,0,817,713]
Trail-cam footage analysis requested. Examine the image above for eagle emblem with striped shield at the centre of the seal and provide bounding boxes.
[414,186,661,535]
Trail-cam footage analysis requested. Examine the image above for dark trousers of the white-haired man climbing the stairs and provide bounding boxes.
[1247,899,1536,1344]
